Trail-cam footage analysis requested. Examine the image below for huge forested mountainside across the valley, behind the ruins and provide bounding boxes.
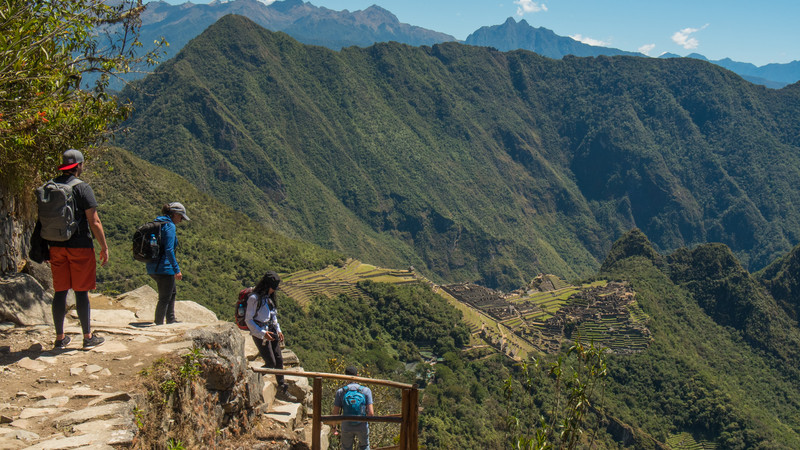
[119,16,800,288]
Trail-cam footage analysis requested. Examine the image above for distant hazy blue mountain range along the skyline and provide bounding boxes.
[133,0,800,89]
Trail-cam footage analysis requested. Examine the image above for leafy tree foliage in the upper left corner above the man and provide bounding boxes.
[0,0,164,202]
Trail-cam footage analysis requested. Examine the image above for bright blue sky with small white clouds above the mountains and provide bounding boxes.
[161,0,800,66]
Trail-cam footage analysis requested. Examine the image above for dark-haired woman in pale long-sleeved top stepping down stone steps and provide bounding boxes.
[245,271,297,402]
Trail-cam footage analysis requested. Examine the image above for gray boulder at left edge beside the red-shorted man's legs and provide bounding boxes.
[0,273,53,325]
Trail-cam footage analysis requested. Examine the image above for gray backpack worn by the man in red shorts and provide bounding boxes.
[36,178,83,242]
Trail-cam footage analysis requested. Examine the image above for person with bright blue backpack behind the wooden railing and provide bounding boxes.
[333,366,375,450]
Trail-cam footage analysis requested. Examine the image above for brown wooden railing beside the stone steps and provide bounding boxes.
[253,368,419,450]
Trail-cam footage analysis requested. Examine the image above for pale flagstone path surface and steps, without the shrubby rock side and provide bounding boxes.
[0,286,329,450]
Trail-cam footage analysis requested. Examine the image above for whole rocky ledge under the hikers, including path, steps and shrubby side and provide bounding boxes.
[0,288,329,449]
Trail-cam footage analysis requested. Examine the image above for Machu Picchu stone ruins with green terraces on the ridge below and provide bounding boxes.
[442,274,650,358]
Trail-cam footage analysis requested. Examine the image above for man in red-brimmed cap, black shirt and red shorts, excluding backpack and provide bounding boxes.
[47,149,108,350]
